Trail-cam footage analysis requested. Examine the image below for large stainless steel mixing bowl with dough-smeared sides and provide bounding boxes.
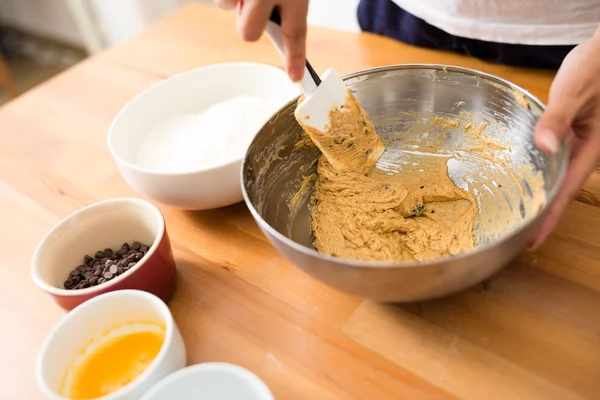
[242,65,567,302]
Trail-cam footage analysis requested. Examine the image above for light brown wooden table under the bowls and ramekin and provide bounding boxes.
[0,5,600,400]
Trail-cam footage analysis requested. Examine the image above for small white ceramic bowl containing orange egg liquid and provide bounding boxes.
[35,290,186,400]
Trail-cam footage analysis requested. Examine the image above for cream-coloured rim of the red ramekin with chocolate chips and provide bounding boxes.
[30,197,165,301]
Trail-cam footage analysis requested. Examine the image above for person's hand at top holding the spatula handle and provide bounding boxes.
[215,0,308,82]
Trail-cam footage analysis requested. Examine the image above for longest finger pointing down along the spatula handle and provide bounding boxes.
[280,0,308,82]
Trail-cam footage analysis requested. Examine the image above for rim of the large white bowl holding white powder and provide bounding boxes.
[106,61,300,177]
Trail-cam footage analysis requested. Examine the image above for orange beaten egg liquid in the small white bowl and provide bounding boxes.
[69,332,164,400]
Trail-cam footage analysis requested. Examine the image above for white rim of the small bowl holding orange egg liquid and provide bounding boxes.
[35,289,175,400]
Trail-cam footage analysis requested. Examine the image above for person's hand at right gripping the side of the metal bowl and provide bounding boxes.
[529,29,600,249]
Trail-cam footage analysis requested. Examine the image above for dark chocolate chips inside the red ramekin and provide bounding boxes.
[64,242,149,290]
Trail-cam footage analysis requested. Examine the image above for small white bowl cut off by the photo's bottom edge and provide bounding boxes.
[140,363,274,400]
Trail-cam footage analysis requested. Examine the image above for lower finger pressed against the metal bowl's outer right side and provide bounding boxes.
[529,132,600,250]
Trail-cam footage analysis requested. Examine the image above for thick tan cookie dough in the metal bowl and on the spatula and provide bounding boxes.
[299,92,478,261]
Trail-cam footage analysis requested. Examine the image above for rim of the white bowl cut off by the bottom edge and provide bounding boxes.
[140,362,275,400]
